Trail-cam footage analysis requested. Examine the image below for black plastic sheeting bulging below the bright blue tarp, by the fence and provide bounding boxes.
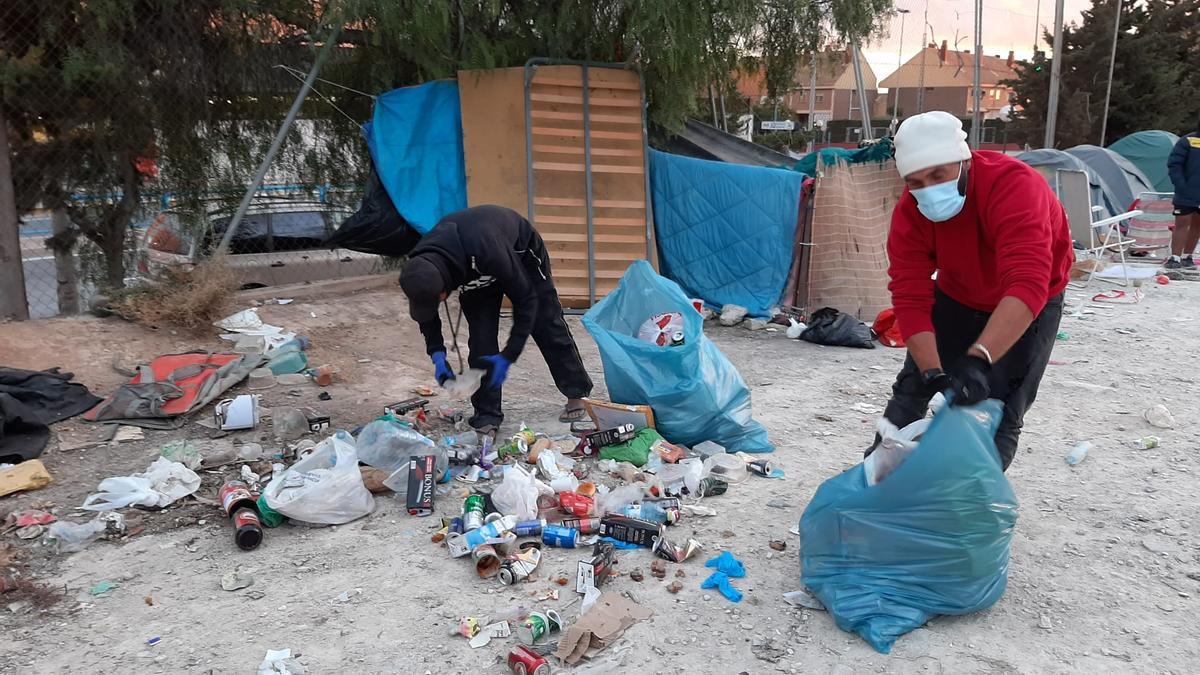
[325,167,421,258]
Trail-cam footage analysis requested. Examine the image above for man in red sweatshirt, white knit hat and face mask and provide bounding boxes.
[866,110,1074,470]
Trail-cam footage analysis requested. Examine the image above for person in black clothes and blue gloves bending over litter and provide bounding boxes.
[400,205,592,437]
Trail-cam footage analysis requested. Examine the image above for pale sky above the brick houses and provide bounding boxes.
[863,0,1092,87]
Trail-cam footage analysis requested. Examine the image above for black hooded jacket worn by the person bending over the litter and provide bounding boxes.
[409,205,538,362]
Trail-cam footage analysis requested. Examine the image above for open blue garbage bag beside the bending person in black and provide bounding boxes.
[583,261,775,453]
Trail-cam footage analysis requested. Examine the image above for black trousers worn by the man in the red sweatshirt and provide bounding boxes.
[872,289,1062,471]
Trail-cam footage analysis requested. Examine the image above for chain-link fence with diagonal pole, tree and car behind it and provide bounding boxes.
[0,0,386,318]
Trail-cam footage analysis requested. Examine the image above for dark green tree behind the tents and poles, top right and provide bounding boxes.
[1012,0,1200,148]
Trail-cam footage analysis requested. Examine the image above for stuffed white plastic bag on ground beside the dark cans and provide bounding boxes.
[263,431,374,525]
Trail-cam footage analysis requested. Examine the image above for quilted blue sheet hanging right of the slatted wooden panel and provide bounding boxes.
[650,150,804,317]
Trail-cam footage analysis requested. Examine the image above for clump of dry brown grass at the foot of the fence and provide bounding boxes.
[109,254,238,333]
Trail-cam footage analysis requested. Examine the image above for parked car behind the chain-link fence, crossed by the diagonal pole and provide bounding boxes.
[138,199,383,288]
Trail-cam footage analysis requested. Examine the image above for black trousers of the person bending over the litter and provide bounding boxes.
[458,235,592,429]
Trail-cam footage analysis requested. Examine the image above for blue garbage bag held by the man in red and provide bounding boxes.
[800,400,1018,653]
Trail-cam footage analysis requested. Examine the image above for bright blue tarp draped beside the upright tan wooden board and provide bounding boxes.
[364,80,467,234]
